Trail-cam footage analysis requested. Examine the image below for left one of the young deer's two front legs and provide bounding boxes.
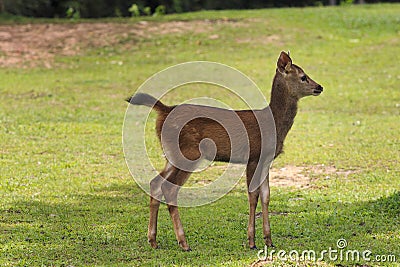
[246,162,259,249]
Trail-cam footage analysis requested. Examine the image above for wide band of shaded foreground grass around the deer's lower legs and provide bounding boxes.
[0,184,400,266]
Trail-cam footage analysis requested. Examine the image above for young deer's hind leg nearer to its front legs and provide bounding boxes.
[161,170,191,251]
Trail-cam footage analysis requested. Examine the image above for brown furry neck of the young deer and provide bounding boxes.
[269,75,299,157]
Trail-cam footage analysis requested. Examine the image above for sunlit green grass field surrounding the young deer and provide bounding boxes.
[0,4,400,266]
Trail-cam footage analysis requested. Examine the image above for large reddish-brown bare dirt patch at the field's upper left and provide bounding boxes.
[0,19,246,68]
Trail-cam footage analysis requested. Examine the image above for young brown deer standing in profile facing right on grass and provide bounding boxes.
[127,52,323,251]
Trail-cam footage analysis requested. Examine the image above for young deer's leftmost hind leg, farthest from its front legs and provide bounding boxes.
[147,162,177,248]
